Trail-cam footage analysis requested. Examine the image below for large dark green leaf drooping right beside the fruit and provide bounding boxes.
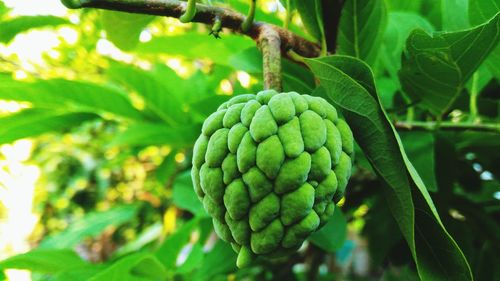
[307,56,472,280]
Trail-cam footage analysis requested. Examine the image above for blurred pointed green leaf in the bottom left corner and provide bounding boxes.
[0,249,88,273]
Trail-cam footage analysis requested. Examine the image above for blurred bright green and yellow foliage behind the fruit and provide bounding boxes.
[0,0,500,281]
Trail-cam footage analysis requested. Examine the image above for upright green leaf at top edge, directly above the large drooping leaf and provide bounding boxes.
[337,0,387,64]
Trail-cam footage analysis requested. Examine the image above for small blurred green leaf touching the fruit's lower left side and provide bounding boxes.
[173,171,206,216]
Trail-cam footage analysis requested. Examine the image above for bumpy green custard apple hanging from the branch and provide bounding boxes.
[192,90,353,267]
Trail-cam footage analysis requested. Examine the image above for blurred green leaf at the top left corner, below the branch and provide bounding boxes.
[0,15,70,44]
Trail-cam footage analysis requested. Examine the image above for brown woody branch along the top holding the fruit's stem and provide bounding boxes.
[62,0,321,57]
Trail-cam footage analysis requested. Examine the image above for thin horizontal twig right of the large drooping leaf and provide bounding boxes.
[394,121,500,133]
